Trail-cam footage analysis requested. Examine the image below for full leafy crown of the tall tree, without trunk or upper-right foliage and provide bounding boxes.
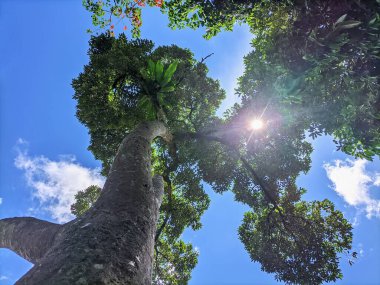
[73,34,352,284]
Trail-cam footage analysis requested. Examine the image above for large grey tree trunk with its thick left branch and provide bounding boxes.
[0,122,169,285]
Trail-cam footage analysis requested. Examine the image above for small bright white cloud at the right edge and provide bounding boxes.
[323,159,380,218]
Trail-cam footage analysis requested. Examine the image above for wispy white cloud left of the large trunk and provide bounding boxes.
[15,139,104,223]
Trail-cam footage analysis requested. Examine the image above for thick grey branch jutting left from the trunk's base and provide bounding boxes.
[0,218,62,264]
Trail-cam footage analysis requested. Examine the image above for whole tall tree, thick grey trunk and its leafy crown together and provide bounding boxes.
[0,34,352,284]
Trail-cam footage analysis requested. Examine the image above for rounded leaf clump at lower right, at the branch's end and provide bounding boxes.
[239,200,352,284]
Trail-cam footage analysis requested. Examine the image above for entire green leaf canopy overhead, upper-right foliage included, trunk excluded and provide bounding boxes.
[74,0,380,284]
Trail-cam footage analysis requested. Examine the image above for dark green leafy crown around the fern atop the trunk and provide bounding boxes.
[73,34,225,174]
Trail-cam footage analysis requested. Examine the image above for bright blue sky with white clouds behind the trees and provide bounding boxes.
[0,0,380,285]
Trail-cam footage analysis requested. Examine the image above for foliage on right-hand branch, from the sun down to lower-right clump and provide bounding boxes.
[199,101,352,284]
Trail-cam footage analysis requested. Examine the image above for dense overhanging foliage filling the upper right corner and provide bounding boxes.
[158,0,380,160]
